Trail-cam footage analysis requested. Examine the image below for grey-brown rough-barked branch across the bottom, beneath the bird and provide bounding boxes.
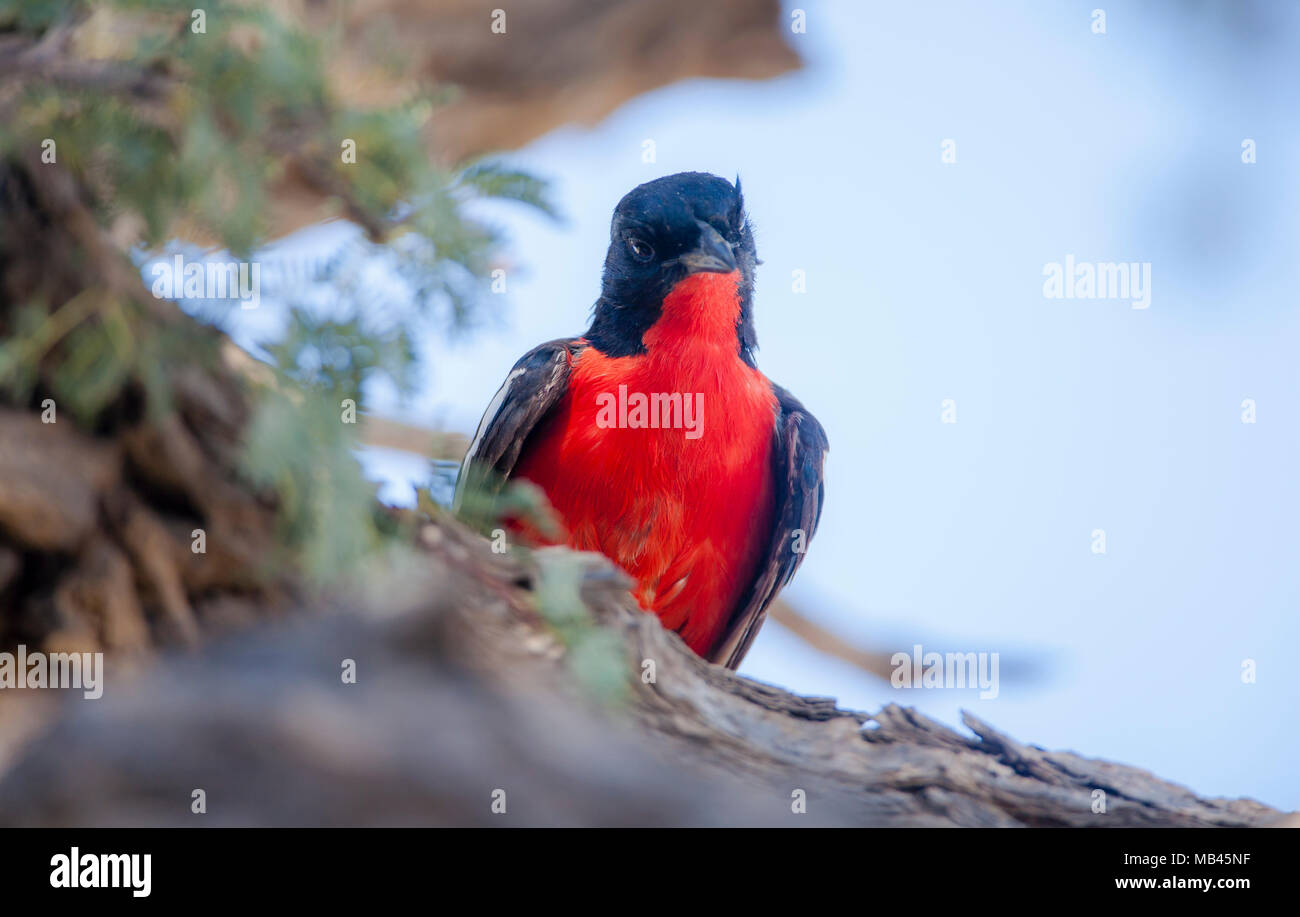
[0,520,1283,826]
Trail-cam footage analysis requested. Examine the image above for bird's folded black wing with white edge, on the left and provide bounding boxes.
[452,338,586,510]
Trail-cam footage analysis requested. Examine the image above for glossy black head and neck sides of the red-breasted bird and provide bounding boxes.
[586,172,758,365]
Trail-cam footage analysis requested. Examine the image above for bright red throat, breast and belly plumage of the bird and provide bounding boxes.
[515,272,776,656]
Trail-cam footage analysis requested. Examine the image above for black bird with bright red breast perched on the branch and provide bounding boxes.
[454,172,829,670]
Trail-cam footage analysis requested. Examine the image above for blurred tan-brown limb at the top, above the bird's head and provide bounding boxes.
[322,0,800,161]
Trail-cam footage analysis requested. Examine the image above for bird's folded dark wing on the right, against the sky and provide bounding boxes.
[709,382,831,669]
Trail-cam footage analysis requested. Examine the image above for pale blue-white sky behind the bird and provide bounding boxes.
[202,0,1300,808]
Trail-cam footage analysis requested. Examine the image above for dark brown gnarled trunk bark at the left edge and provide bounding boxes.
[0,160,293,652]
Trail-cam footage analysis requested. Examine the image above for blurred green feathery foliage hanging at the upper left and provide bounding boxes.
[0,0,551,580]
